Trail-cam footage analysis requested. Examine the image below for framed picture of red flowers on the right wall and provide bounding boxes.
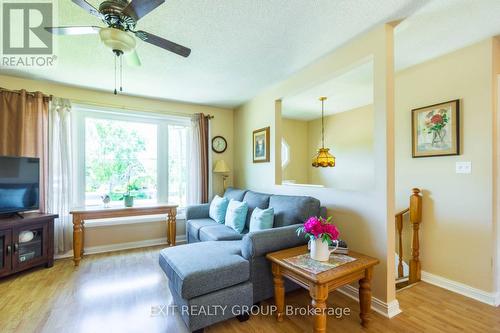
[411,99,460,158]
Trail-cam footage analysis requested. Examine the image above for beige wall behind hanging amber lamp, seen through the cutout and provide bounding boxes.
[307,105,375,191]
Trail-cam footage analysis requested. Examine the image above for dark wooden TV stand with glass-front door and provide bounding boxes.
[0,213,58,277]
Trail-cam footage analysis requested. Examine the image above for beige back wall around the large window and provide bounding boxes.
[0,75,234,247]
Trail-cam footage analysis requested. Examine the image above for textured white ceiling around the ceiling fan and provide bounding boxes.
[0,0,427,107]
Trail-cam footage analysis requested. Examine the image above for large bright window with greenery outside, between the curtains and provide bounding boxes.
[72,107,190,207]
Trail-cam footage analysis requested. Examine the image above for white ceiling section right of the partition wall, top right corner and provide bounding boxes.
[394,0,500,69]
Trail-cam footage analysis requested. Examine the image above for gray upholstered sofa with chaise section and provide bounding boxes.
[160,188,326,331]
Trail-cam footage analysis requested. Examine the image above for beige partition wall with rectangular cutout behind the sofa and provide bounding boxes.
[234,25,395,302]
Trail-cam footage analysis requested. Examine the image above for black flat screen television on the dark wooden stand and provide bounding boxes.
[0,156,40,214]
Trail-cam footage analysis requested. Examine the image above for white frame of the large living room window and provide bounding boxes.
[71,104,191,214]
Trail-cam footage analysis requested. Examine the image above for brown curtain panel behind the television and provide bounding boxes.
[0,89,49,212]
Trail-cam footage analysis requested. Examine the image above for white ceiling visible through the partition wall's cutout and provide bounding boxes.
[282,61,373,120]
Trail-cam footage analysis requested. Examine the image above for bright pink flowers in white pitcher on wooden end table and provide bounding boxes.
[297,216,339,261]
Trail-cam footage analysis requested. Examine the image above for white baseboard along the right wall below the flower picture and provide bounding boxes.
[421,271,500,306]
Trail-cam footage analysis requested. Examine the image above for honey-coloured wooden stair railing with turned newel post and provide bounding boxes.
[395,188,422,284]
